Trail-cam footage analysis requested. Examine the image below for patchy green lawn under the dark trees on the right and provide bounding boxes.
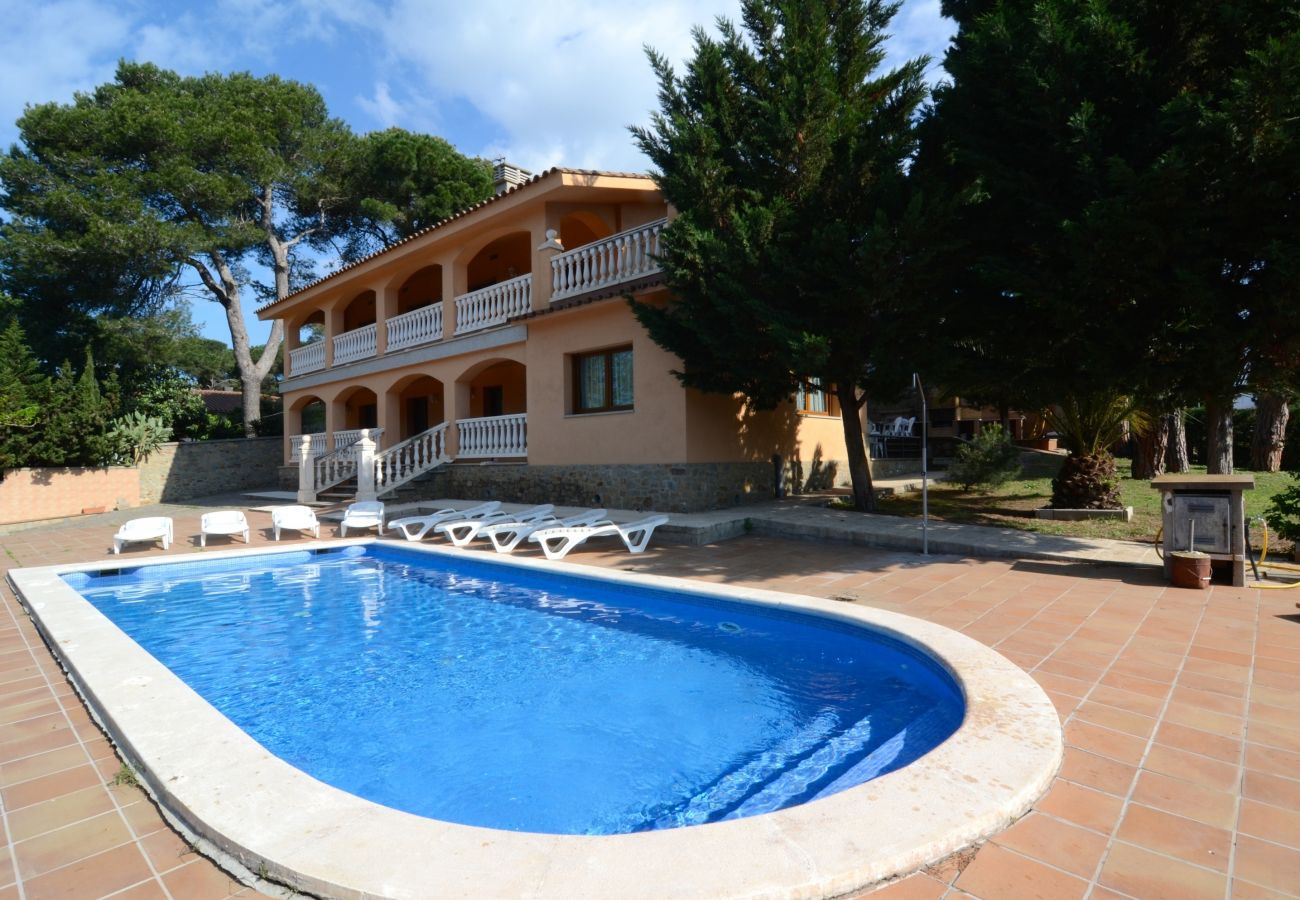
[879,453,1294,548]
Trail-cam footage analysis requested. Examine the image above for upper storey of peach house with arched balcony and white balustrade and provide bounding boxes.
[257,169,668,381]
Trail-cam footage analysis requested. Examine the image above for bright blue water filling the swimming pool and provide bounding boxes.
[65,545,965,834]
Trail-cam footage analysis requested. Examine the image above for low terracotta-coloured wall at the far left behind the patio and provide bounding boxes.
[0,466,140,525]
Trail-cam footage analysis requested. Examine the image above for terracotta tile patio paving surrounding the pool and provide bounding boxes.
[0,498,1300,900]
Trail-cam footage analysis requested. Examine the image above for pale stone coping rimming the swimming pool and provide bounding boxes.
[9,537,1063,897]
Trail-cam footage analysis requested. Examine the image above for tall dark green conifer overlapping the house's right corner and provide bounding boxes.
[632,0,939,510]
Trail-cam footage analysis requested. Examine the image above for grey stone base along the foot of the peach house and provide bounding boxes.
[419,463,772,512]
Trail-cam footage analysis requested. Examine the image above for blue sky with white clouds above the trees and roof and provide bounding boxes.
[0,0,953,343]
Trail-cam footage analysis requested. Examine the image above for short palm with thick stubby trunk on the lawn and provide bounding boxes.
[1048,394,1151,510]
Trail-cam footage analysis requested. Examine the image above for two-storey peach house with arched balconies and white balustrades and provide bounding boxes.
[257,165,863,511]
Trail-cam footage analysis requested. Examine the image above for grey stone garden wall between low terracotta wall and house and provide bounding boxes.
[140,437,283,503]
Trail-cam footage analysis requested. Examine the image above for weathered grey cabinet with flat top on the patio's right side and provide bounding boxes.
[1151,475,1255,588]
